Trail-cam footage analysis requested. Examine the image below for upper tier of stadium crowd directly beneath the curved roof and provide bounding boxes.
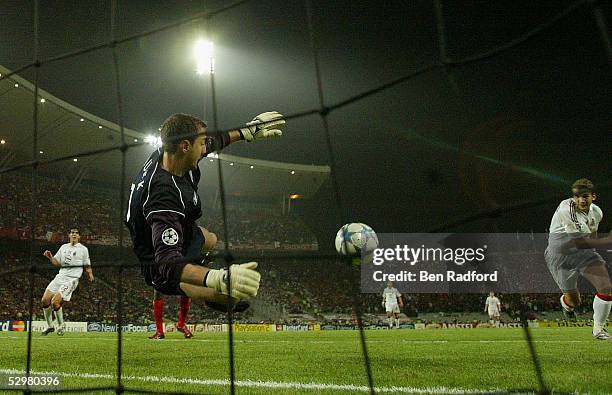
[0,172,318,250]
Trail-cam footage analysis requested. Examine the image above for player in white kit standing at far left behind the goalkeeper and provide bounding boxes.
[41,227,94,336]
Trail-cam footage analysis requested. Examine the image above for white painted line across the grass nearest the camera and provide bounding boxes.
[0,369,508,395]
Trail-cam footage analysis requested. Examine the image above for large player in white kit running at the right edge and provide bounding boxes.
[544,178,612,340]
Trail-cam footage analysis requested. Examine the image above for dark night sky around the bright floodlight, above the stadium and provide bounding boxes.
[0,0,612,248]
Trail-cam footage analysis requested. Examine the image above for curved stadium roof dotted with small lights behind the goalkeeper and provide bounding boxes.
[0,66,330,201]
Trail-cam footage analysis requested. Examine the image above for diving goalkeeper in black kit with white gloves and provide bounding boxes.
[125,112,285,306]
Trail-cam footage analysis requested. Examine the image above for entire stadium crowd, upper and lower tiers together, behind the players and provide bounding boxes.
[0,172,604,323]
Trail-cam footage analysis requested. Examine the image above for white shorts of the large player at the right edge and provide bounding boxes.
[544,248,605,292]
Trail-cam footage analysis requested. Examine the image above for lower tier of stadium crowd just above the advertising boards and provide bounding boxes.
[0,244,588,324]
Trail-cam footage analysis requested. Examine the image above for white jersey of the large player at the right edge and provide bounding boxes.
[548,198,603,254]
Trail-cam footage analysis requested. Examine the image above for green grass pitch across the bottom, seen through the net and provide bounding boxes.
[0,328,612,395]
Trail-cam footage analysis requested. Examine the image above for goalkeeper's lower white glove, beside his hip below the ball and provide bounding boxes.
[206,262,261,299]
